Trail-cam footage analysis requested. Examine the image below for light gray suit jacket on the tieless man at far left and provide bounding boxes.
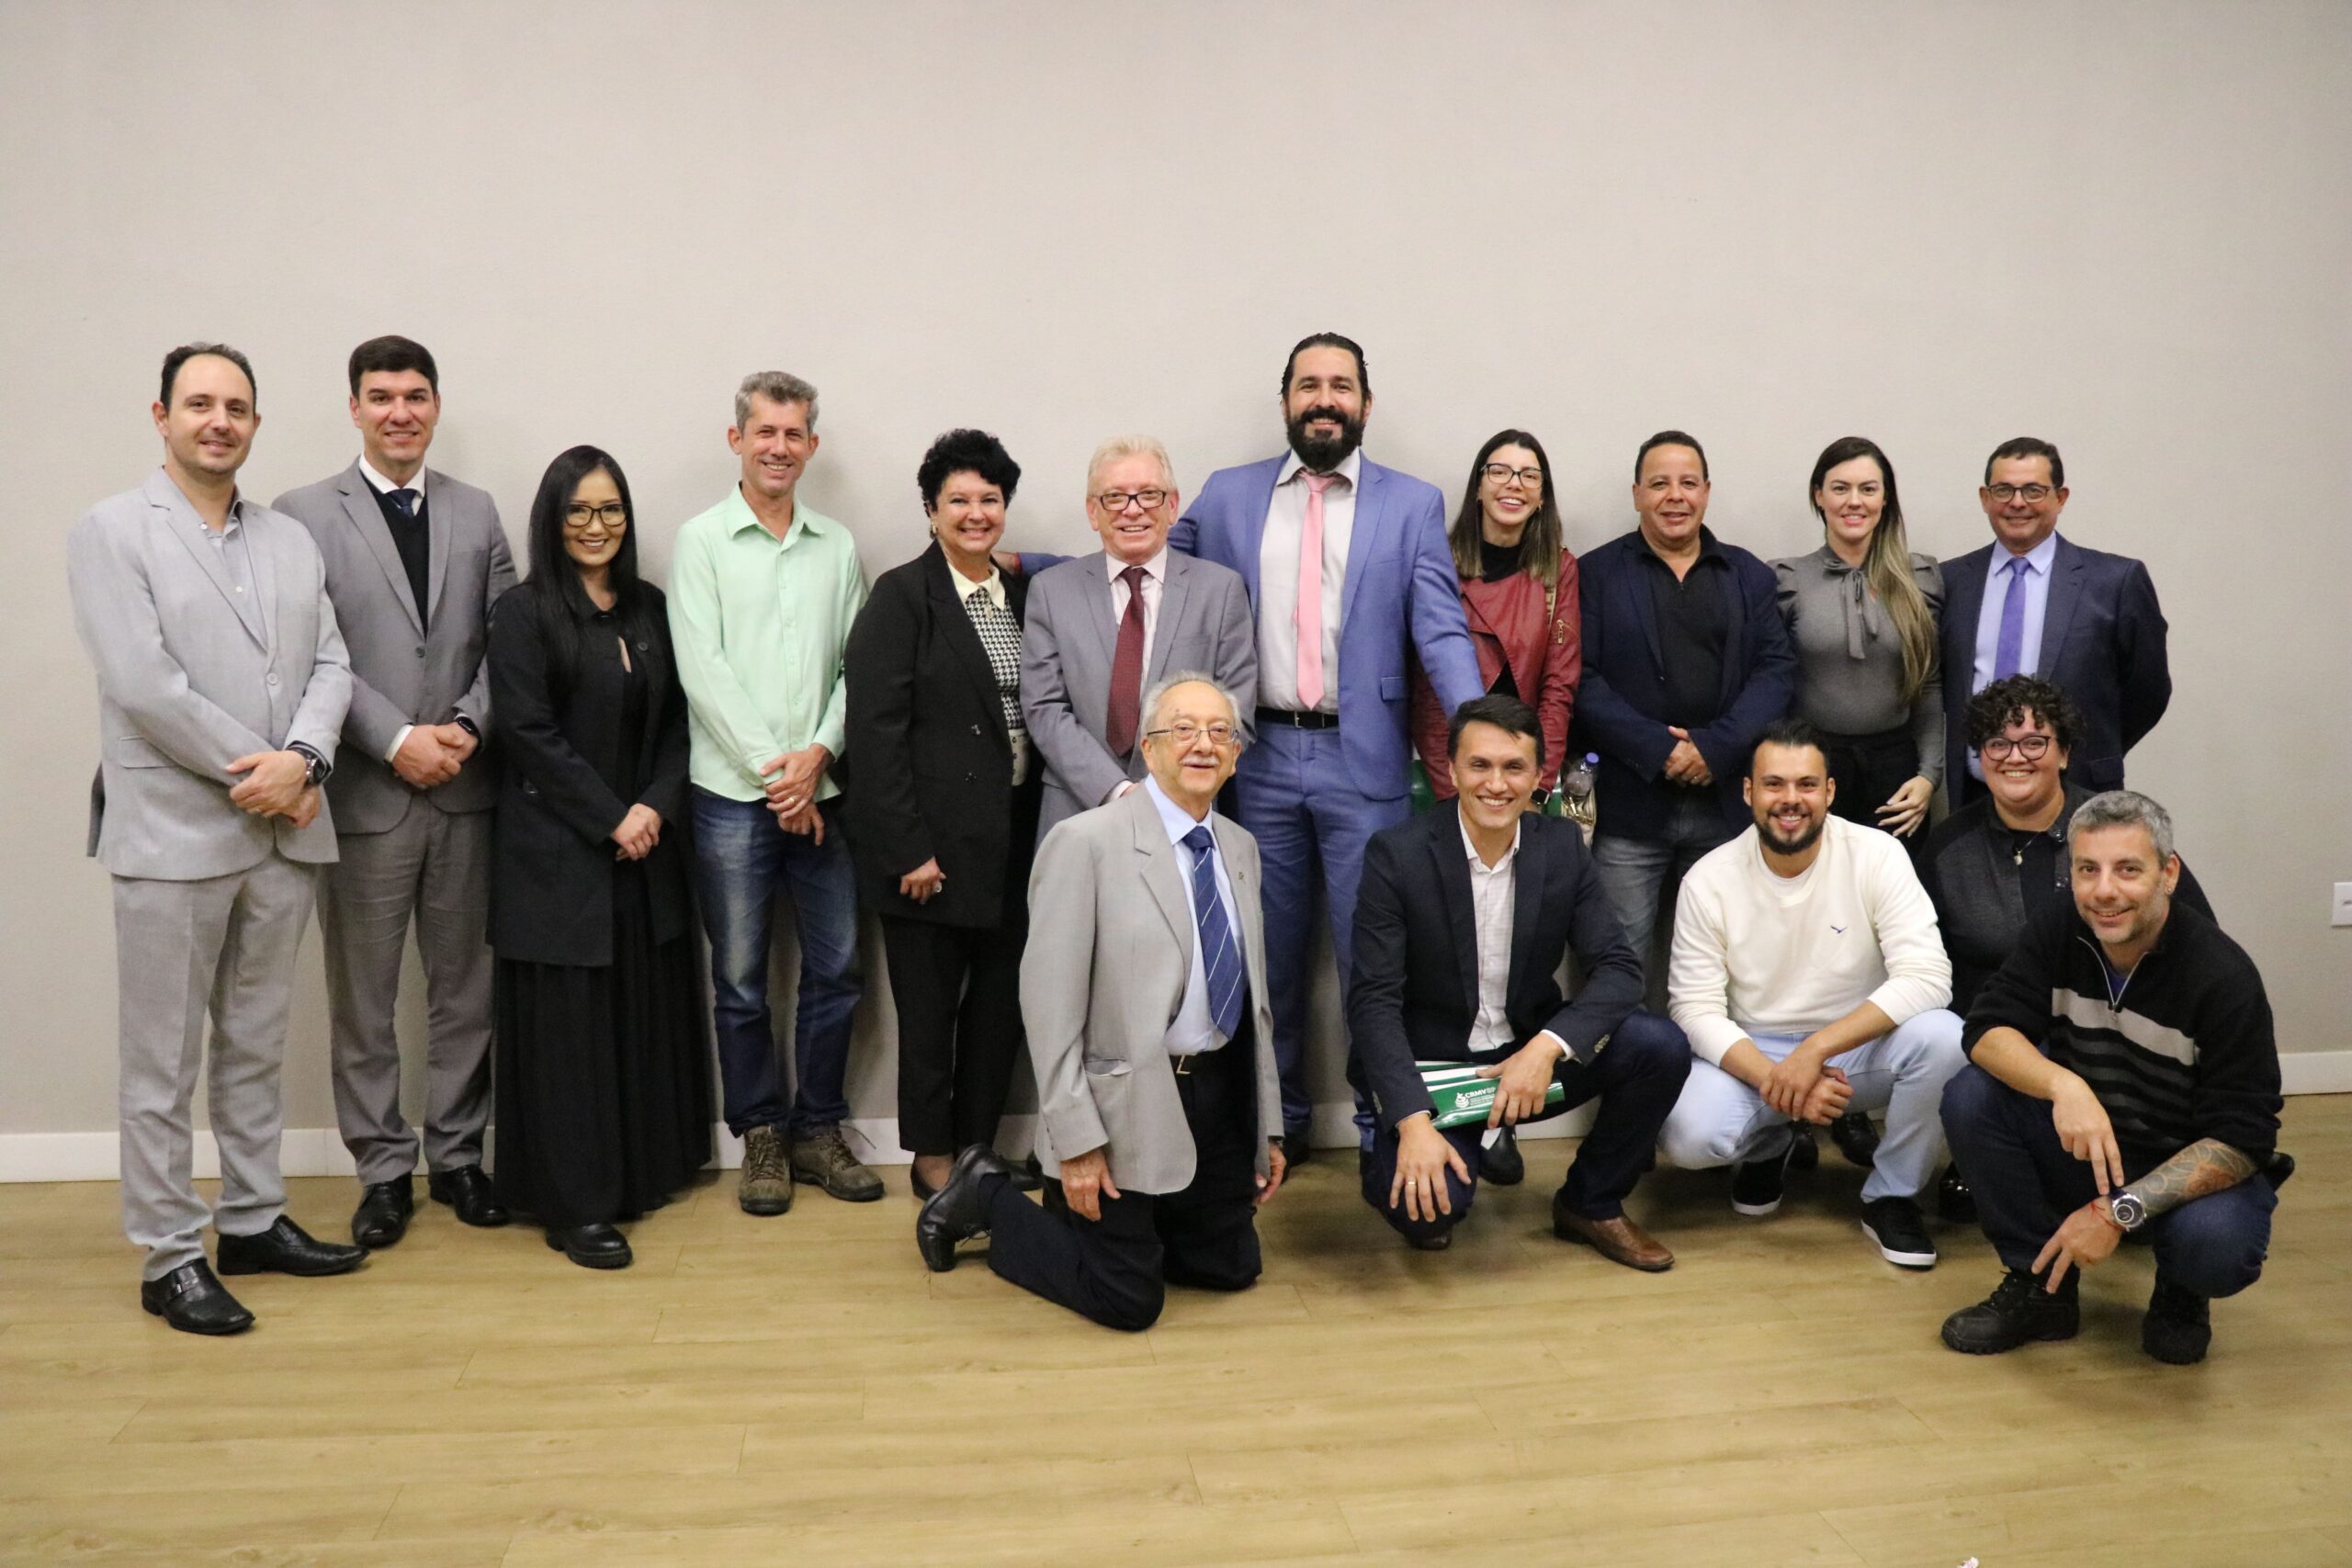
[66,468,350,882]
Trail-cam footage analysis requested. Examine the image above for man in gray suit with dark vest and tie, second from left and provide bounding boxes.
[277,336,515,1248]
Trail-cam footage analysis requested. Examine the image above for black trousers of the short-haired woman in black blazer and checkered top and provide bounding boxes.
[882,915,1028,1155]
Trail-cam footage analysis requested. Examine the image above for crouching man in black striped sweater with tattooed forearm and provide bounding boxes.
[1943,790,2293,1366]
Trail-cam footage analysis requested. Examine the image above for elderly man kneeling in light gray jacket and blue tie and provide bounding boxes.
[915,672,1284,1331]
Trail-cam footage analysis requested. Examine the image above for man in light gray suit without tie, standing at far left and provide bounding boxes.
[66,344,367,1333]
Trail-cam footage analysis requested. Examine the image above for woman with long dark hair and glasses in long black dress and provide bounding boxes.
[489,446,710,1269]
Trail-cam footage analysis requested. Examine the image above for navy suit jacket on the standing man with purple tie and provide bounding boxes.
[1943,534,2173,804]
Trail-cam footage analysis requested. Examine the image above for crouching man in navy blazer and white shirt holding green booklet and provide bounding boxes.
[1348,696,1691,1272]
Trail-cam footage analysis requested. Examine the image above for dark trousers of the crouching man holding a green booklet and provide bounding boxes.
[1357,1009,1691,1239]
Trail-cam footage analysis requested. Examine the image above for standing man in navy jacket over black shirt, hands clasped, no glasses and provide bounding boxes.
[1576,430,1797,964]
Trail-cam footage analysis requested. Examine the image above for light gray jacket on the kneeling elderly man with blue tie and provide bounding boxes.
[1021,790,1282,1192]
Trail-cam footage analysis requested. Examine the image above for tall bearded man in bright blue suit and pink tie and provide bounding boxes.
[1169,332,1476,1146]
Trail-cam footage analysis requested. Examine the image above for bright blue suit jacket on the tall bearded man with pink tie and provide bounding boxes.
[1169,458,1476,799]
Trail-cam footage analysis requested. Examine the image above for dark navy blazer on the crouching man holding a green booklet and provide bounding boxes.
[1348,802,1642,1126]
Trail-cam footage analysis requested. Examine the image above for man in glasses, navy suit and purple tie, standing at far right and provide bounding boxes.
[1943,434,2173,807]
